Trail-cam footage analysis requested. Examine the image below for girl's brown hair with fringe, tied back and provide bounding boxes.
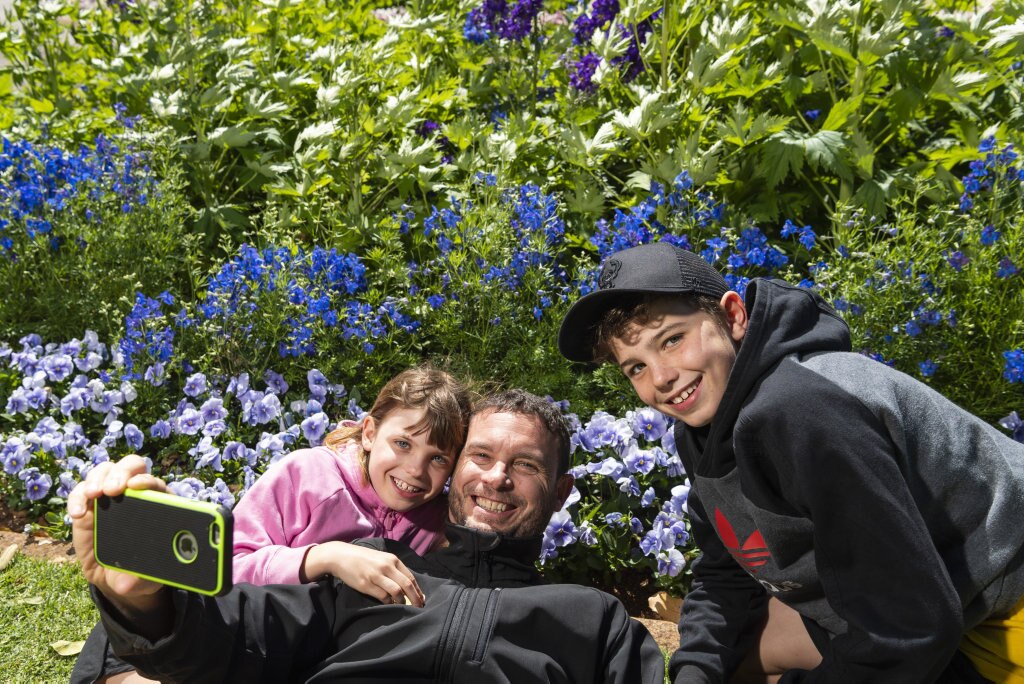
[324,366,472,482]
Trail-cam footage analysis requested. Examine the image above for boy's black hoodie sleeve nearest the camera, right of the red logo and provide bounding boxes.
[755,387,966,682]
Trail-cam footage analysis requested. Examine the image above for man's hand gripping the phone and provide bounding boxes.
[68,455,167,606]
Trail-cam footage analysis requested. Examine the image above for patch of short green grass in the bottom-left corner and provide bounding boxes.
[0,555,98,684]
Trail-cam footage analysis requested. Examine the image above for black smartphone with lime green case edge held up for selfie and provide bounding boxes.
[92,489,232,596]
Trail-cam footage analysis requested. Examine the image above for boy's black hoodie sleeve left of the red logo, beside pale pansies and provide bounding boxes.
[669,490,768,684]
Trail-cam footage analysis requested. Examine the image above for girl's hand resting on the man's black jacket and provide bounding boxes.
[301,542,425,608]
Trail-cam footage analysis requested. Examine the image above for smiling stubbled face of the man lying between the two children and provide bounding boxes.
[449,411,572,537]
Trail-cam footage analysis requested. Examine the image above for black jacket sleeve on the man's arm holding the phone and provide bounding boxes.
[92,581,341,684]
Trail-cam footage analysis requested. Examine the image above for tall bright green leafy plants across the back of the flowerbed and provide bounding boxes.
[0,0,1024,241]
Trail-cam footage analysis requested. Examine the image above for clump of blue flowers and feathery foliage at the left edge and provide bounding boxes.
[0,129,203,339]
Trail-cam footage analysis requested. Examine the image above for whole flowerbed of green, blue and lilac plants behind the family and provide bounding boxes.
[0,0,1024,675]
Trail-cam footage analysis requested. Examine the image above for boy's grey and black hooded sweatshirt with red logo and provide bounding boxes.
[670,279,1024,684]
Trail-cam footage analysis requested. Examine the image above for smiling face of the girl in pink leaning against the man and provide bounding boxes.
[362,409,455,511]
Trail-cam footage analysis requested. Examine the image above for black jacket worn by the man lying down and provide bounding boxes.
[93,525,665,684]
